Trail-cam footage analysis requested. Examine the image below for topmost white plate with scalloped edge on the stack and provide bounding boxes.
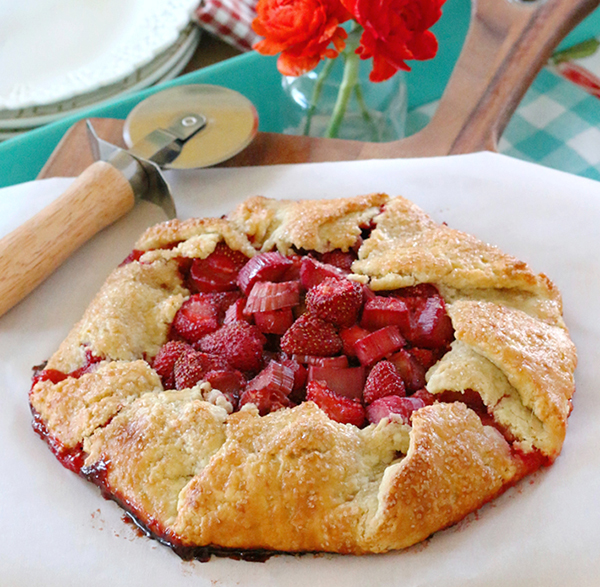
[0,0,198,110]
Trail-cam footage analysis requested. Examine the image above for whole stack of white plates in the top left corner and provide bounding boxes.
[0,0,200,140]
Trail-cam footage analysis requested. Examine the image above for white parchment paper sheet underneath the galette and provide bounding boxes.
[0,153,600,587]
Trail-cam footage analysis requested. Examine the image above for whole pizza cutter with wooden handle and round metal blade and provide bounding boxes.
[0,84,258,316]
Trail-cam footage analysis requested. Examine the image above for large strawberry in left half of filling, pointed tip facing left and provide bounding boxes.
[198,321,266,372]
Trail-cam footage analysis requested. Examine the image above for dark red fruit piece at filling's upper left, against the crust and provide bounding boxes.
[190,242,248,292]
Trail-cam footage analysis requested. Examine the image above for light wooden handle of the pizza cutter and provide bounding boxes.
[0,161,135,316]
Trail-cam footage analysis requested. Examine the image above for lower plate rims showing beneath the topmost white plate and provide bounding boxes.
[0,25,201,134]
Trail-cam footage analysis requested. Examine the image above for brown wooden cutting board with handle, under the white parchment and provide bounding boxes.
[39,0,600,178]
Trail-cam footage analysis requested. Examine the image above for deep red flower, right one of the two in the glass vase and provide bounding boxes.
[342,0,445,82]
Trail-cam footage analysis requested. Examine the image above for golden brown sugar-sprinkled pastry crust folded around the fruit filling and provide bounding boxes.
[31,194,576,554]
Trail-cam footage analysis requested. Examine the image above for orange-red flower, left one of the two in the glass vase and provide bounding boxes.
[252,0,352,76]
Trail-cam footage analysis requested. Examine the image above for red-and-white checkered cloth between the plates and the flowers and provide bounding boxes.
[196,0,260,51]
